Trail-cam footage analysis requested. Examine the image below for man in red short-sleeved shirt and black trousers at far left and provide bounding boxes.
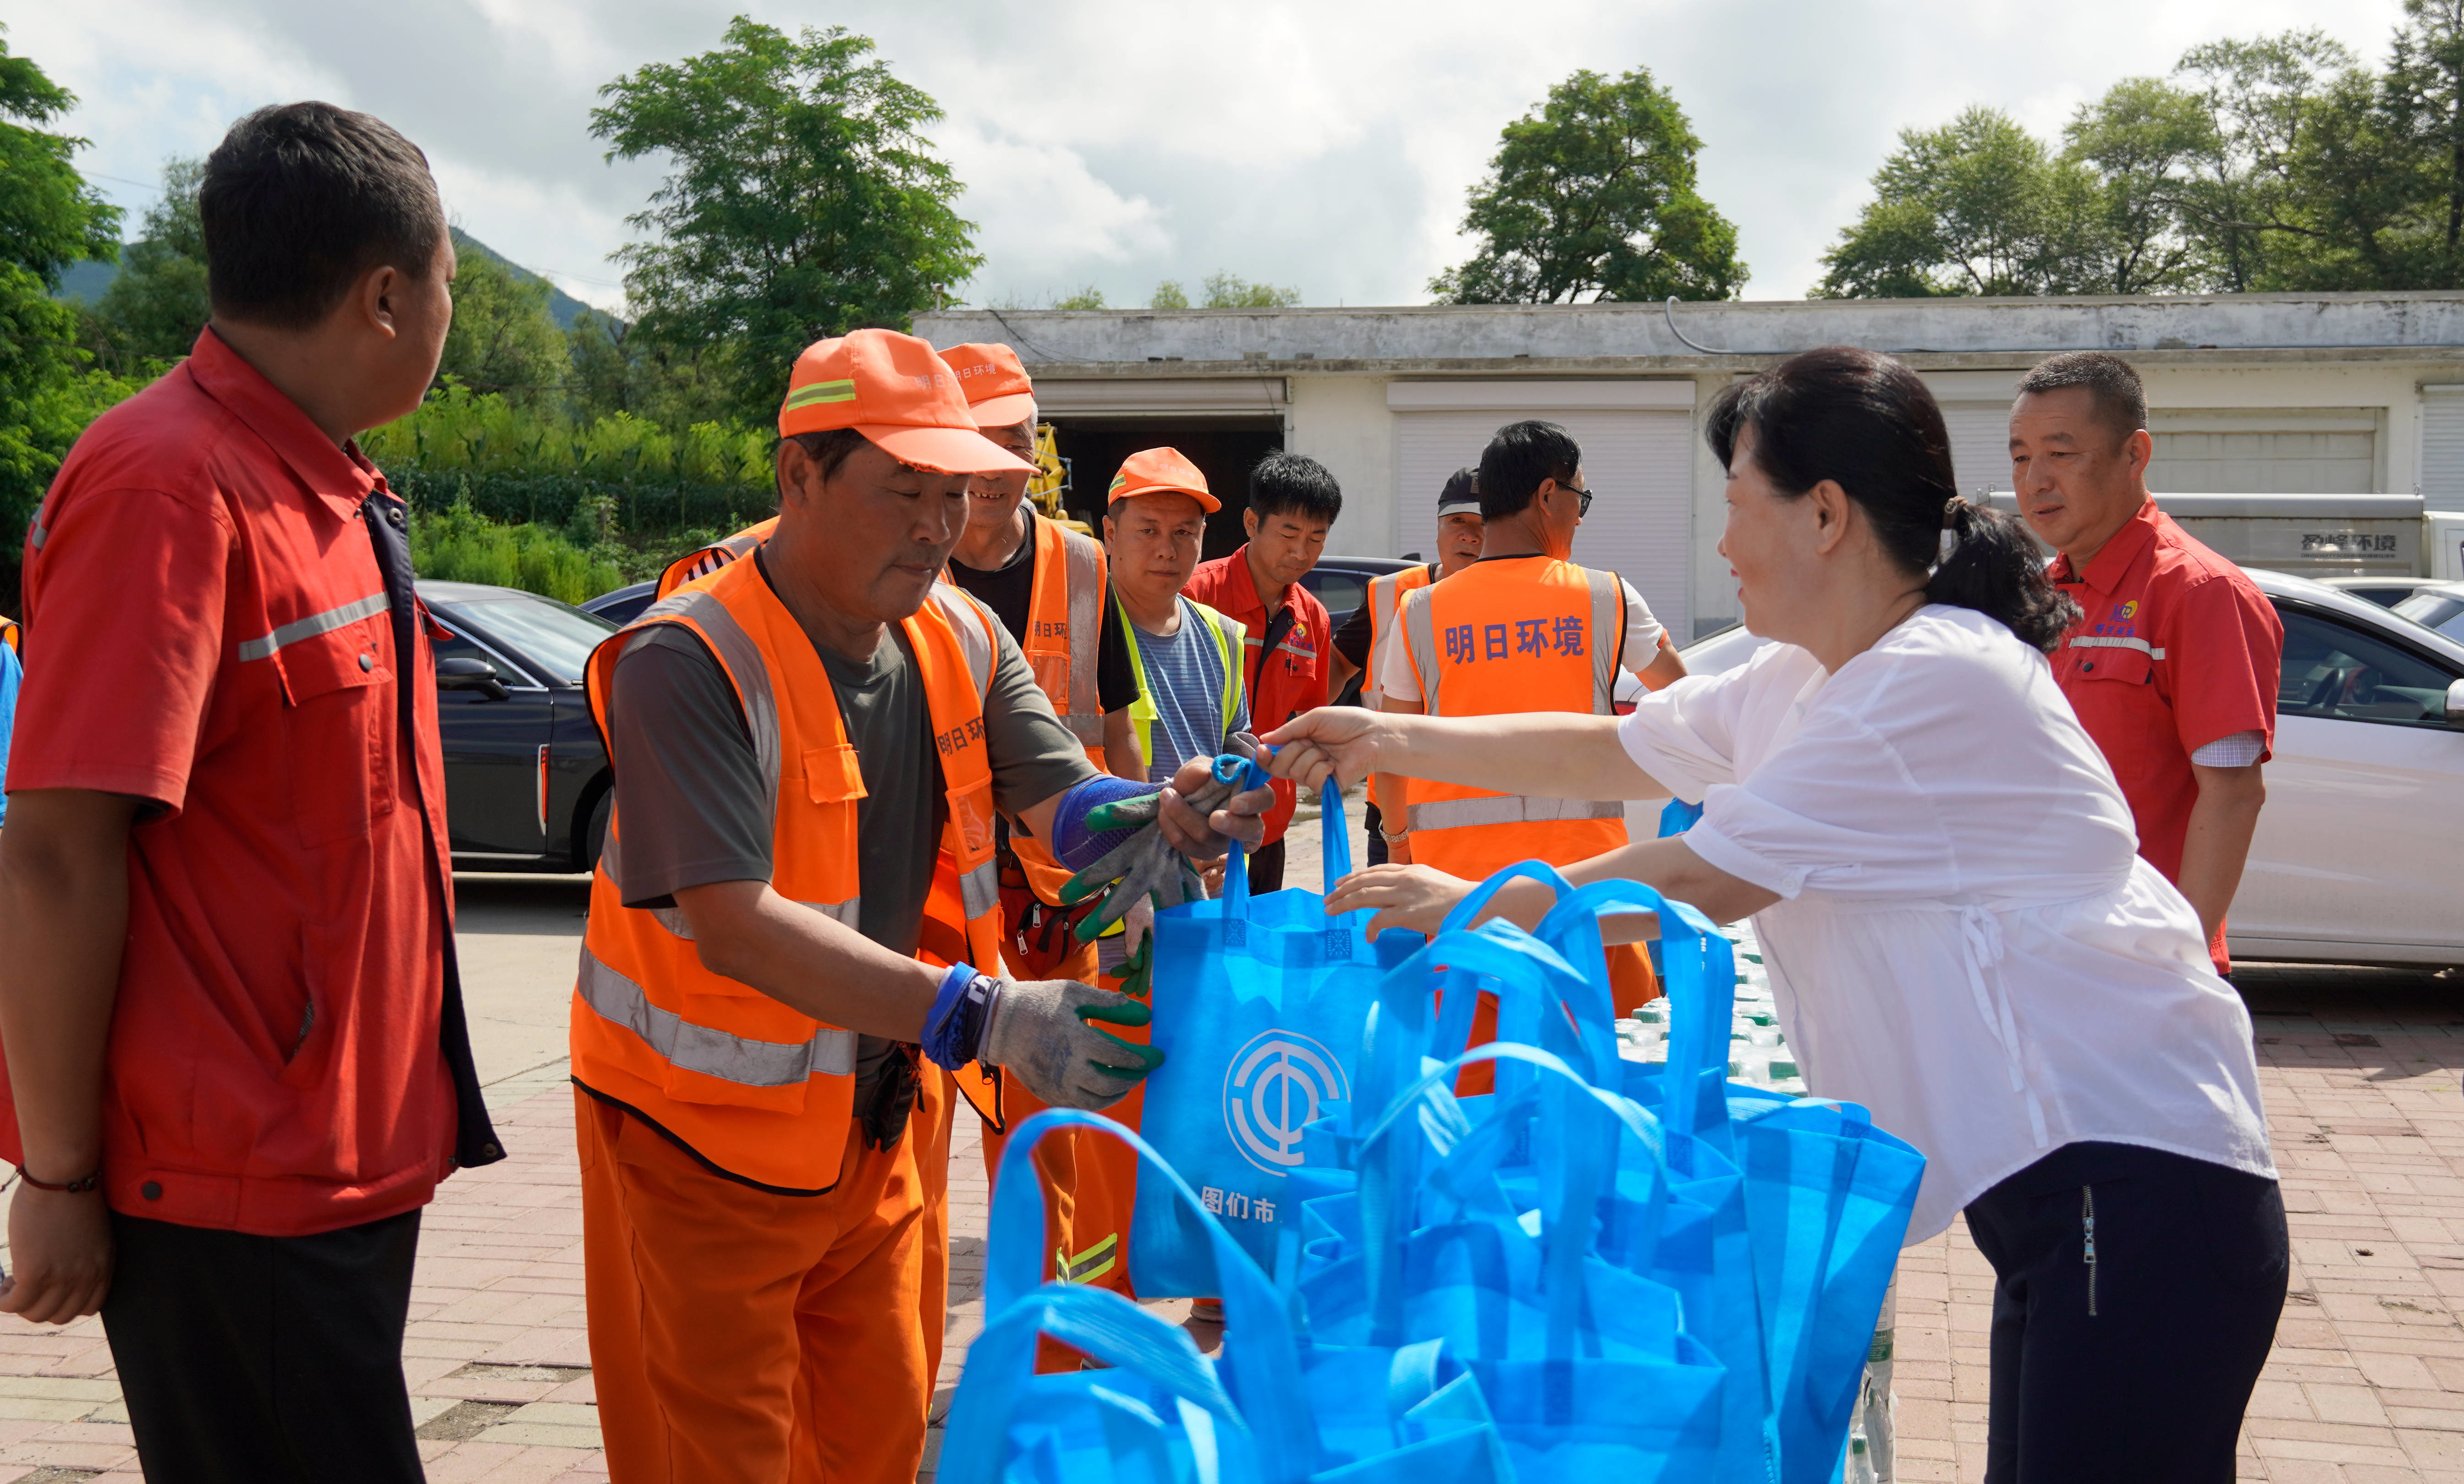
[0,104,503,1484]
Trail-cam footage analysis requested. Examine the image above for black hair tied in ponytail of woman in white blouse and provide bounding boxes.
[1703,345,2079,651]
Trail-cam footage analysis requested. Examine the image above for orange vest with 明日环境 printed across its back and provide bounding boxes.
[1402,557,1626,880]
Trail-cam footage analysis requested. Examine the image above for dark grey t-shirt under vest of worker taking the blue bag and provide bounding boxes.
[606,559,1096,1072]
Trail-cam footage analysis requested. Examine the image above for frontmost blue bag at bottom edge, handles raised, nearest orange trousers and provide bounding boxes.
[941,1109,1513,1484]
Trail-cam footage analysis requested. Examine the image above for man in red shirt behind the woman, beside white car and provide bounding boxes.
[2011,350,2284,974]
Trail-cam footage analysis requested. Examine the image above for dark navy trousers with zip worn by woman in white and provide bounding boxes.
[1969,1144,2287,1484]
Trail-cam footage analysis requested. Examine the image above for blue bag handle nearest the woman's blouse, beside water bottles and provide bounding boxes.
[1540,880,1737,1154]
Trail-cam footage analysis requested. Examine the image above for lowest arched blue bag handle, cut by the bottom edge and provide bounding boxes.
[941,1284,1259,1484]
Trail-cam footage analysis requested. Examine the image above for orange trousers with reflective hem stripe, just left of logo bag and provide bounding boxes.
[983,944,1146,1299]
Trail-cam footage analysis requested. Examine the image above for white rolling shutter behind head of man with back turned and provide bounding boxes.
[1395,412,1693,643]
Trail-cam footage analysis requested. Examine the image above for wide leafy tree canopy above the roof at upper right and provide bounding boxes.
[1816,0,2464,296]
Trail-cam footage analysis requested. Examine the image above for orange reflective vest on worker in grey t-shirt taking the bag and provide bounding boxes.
[572,550,1001,1196]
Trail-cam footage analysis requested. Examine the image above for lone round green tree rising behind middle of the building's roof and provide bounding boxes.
[1429,66,1744,303]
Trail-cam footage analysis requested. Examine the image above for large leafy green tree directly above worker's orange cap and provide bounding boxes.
[591,15,983,422]
